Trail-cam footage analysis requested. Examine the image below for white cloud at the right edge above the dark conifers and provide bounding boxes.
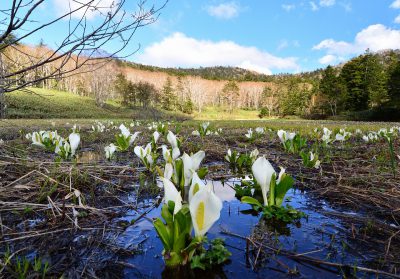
[313,24,400,60]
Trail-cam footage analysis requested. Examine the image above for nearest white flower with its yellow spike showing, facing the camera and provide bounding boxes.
[189,184,222,237]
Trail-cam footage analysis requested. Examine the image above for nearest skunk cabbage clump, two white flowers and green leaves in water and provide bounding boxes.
[154,173,230,269]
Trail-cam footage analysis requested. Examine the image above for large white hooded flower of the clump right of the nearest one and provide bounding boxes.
[251,156,276,205]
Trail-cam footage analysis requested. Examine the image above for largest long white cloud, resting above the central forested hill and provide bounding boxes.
[137,33,299,74]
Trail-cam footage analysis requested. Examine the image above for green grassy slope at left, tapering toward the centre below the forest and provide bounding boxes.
[6,88,187,119]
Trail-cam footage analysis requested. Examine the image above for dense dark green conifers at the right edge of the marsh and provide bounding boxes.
[315,50,400,120]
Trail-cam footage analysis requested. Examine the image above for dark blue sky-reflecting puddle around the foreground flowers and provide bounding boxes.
[110,181,382,278]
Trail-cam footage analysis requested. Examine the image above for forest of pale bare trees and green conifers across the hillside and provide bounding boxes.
[1,42,400,121]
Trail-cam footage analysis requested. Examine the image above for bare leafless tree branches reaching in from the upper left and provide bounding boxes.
[0,0,168,118]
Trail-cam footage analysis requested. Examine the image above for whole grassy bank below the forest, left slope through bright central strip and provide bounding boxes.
[6,88,266,120]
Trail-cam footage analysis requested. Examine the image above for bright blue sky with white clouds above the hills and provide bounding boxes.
[7,0,400,73]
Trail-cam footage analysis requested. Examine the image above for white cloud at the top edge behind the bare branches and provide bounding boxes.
[53,0,116,19]
